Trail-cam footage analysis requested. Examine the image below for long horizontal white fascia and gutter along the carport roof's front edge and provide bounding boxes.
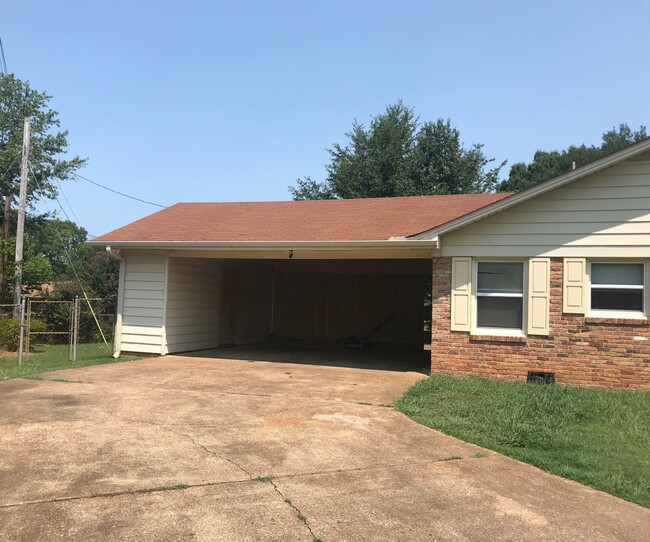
[87,238,438,251]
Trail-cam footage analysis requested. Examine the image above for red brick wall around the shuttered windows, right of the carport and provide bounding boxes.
[431,258,650,389]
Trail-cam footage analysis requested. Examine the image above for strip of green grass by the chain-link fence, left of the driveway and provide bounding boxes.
[0,343,136,381]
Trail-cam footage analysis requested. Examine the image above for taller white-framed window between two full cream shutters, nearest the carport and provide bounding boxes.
[476,262,524,329]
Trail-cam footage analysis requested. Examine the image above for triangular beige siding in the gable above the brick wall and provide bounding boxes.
[441,160,650,258]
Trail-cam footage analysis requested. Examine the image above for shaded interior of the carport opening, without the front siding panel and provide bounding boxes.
[166,257,431,353]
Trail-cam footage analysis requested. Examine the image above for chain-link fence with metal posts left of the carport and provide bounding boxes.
[0,297,115,368]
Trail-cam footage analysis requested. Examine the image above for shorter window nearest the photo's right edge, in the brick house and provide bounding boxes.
[591,263,645,312]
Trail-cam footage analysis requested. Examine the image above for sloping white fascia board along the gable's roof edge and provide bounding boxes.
[409,137,650,240]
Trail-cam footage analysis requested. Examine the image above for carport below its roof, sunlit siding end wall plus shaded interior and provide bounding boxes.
[118,250,431,366]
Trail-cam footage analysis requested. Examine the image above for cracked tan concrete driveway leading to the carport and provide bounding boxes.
[0,350,650,542]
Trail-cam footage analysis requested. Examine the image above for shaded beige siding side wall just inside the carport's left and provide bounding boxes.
[165,258,221,353]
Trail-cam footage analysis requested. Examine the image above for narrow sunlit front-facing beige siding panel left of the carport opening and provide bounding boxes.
[120,251,167,354]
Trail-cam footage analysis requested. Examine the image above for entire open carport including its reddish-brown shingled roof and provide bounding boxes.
[91,194,503,366]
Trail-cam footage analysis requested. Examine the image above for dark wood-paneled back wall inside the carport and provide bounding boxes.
[273,261,429,345]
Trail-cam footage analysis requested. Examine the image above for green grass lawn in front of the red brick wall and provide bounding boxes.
[395,375,650,507]
